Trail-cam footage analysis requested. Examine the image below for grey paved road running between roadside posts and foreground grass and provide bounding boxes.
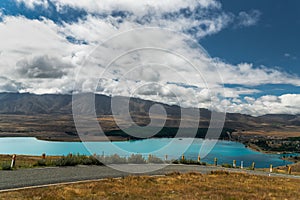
[0,165,300,192]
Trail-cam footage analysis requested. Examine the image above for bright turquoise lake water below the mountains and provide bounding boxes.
[0,137,291,168]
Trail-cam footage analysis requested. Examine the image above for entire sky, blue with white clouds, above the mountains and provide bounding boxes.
[0,0,300,116]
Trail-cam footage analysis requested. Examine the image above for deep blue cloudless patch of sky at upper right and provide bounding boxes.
[201,0,300,75]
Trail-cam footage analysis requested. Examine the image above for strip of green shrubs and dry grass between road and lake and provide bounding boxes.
[0,154,300,174]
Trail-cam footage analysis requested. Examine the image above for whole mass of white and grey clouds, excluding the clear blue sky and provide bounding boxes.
[0,0,300,115]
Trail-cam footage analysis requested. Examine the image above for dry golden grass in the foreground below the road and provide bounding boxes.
[0,172,300,200]
